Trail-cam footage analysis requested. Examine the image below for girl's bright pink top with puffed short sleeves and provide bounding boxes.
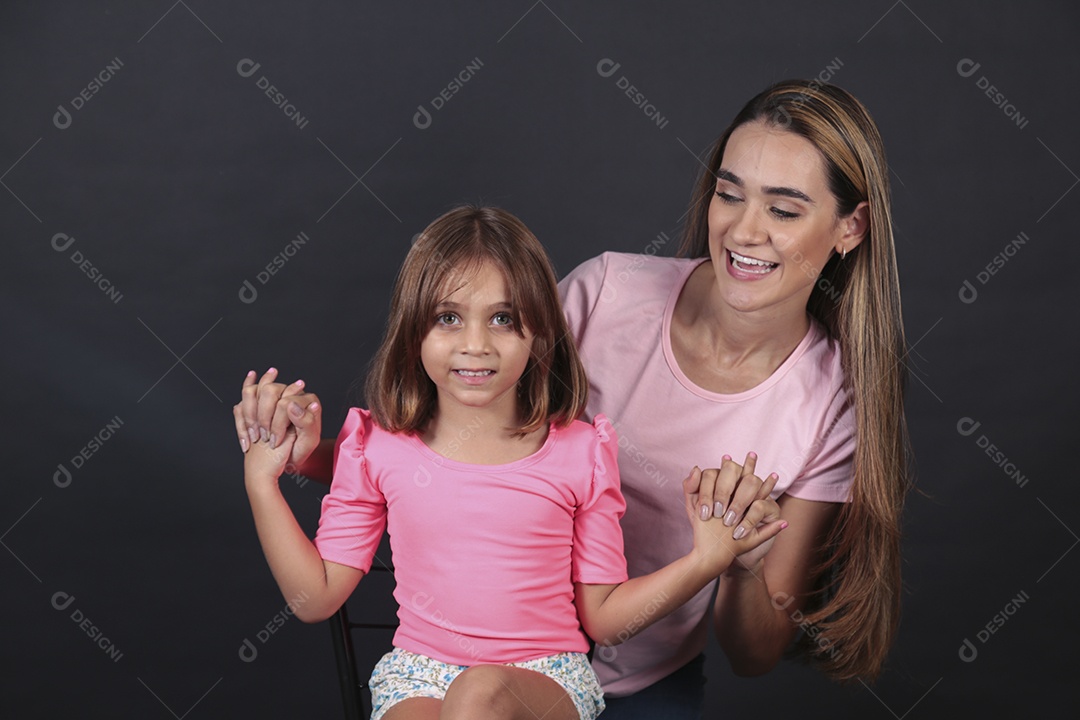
[315,408,626,665]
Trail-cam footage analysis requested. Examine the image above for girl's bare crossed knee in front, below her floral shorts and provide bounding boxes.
[438,665,580,720]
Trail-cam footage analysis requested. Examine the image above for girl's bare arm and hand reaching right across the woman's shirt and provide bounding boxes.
[575,463,787,646]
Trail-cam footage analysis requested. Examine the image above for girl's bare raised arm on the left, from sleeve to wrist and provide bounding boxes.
[244,433,364,623]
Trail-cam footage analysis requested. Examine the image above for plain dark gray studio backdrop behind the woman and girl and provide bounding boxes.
[0,0,1080,718]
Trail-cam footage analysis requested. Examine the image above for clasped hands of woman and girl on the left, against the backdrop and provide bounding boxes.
[232,368,323,466]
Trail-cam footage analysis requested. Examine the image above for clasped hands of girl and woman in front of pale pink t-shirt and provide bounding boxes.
[683,464,787,575]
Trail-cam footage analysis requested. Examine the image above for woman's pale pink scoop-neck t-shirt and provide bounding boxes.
[559,253,854,696]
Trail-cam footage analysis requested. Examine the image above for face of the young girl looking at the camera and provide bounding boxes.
[420,262,532,424]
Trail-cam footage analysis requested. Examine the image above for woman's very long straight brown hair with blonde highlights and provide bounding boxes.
[680,80,910,680]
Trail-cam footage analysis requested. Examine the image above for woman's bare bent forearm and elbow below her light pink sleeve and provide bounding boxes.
[713,495,840,677]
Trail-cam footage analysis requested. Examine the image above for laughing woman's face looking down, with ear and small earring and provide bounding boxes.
[708,122,867,318]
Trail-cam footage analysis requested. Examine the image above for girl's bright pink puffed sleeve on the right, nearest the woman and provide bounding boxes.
[572,415,627,585]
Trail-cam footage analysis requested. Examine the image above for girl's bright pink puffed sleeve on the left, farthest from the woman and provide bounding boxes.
[315,408,387,572]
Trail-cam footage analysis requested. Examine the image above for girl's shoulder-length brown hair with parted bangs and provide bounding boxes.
[365,205,589,434]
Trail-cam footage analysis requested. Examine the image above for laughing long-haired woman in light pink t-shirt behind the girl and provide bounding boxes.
[237,81,908,718]
